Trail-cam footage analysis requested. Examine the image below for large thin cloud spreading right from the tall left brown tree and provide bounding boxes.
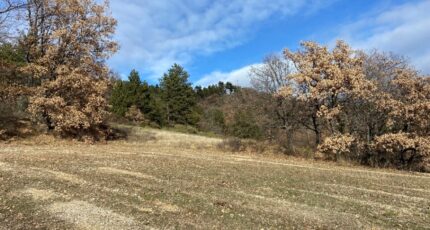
[109,0,333,78]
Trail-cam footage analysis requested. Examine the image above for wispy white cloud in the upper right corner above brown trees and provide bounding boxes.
[338,0,430,74]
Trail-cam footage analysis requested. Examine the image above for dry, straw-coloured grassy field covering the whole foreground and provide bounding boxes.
[0,128,430,229]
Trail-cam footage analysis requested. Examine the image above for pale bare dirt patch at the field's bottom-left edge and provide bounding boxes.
[47,201,139,230]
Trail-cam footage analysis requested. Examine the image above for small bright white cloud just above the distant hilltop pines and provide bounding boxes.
[194,64,261,87]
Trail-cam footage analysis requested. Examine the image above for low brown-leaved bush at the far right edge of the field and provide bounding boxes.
[367,133,430,172]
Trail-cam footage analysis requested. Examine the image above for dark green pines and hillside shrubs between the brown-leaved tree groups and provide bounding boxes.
[108,64,261,138]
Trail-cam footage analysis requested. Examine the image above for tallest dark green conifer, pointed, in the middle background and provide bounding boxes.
[160,64,198,125]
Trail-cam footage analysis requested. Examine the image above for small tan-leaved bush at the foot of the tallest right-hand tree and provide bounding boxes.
[316,135,363,161]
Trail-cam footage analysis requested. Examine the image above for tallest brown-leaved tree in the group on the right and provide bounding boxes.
[280,41,373,145]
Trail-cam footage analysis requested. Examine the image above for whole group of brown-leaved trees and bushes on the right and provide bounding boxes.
[277,41,430,171]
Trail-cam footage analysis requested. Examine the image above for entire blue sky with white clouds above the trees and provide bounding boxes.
[108,0,430,86]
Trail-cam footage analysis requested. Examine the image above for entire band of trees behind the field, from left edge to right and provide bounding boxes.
[0,0,430,171]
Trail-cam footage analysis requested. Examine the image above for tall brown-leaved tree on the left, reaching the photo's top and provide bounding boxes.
[24,0,117,140]
